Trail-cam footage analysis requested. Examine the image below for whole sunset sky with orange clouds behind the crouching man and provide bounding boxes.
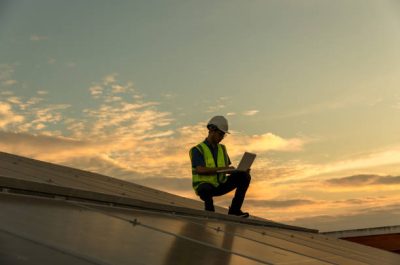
[0,0,400,231]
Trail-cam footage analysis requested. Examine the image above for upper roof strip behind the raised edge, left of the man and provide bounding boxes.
[0,152,206,210]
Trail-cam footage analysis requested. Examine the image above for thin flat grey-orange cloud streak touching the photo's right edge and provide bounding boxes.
[326,175,400,187]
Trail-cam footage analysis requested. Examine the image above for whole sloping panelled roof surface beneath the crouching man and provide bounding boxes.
[0,153,400,265]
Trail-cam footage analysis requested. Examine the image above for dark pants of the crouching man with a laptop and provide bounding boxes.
[197,172,251,212]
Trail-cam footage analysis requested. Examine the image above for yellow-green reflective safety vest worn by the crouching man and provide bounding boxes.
[189,142,228,194]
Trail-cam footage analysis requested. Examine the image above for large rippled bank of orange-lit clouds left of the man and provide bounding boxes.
[0,74,186,178]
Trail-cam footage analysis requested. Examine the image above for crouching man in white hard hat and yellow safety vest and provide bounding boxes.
[190,116,251,217]
